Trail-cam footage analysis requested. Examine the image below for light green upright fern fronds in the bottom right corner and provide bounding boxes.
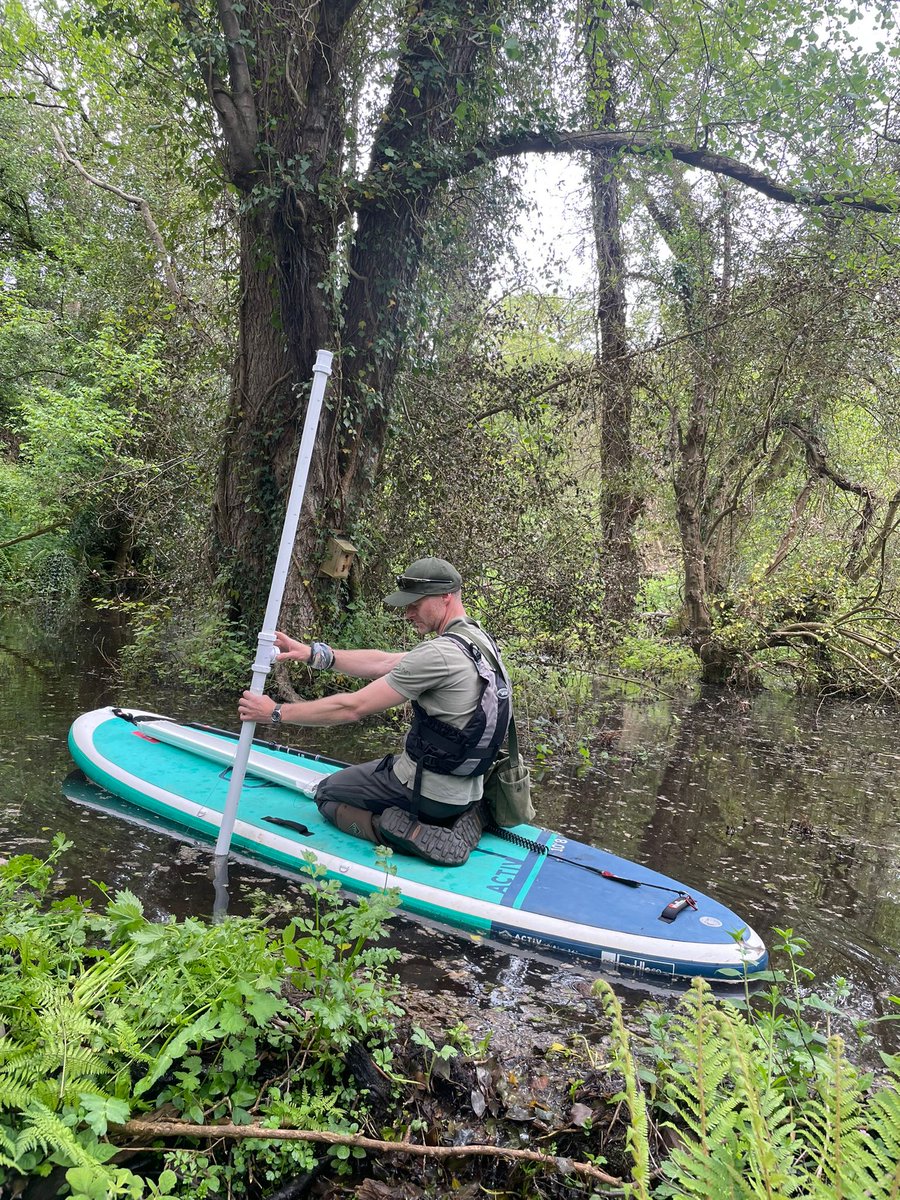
[594,930,900,1200]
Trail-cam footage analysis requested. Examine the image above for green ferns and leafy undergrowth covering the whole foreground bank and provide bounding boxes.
[0,839,900,1200]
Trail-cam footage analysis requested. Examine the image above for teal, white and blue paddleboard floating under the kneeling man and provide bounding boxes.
[70,708,767,982]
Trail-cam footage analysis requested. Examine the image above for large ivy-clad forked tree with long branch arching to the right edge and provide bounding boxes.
[187,0,893,620]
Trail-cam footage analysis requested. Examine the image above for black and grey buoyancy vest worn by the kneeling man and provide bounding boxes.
[406,634,512,799]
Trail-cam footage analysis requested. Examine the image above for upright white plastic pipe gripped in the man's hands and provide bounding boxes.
[216,350,334,857]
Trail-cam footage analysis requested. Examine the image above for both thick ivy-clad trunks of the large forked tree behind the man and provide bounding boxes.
[195,0,501,630]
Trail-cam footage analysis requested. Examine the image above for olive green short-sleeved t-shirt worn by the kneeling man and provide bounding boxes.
[385,617,501,805]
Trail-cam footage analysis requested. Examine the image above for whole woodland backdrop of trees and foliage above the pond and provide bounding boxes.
[0,0,900,696]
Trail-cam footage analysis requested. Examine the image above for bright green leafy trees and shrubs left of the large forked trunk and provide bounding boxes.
[0,0,229,599]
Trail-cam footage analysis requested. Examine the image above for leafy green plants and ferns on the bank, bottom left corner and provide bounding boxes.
[0,839,400,1200]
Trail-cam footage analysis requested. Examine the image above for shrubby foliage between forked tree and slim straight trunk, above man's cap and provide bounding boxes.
[362,289,602,638]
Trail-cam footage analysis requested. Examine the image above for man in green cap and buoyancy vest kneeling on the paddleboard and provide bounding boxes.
[238,558,512,866]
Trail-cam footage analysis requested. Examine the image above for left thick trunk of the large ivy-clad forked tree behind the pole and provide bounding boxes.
[194,0,358,624]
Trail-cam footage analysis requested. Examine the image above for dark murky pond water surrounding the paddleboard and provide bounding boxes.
[0,613,900,1049]
